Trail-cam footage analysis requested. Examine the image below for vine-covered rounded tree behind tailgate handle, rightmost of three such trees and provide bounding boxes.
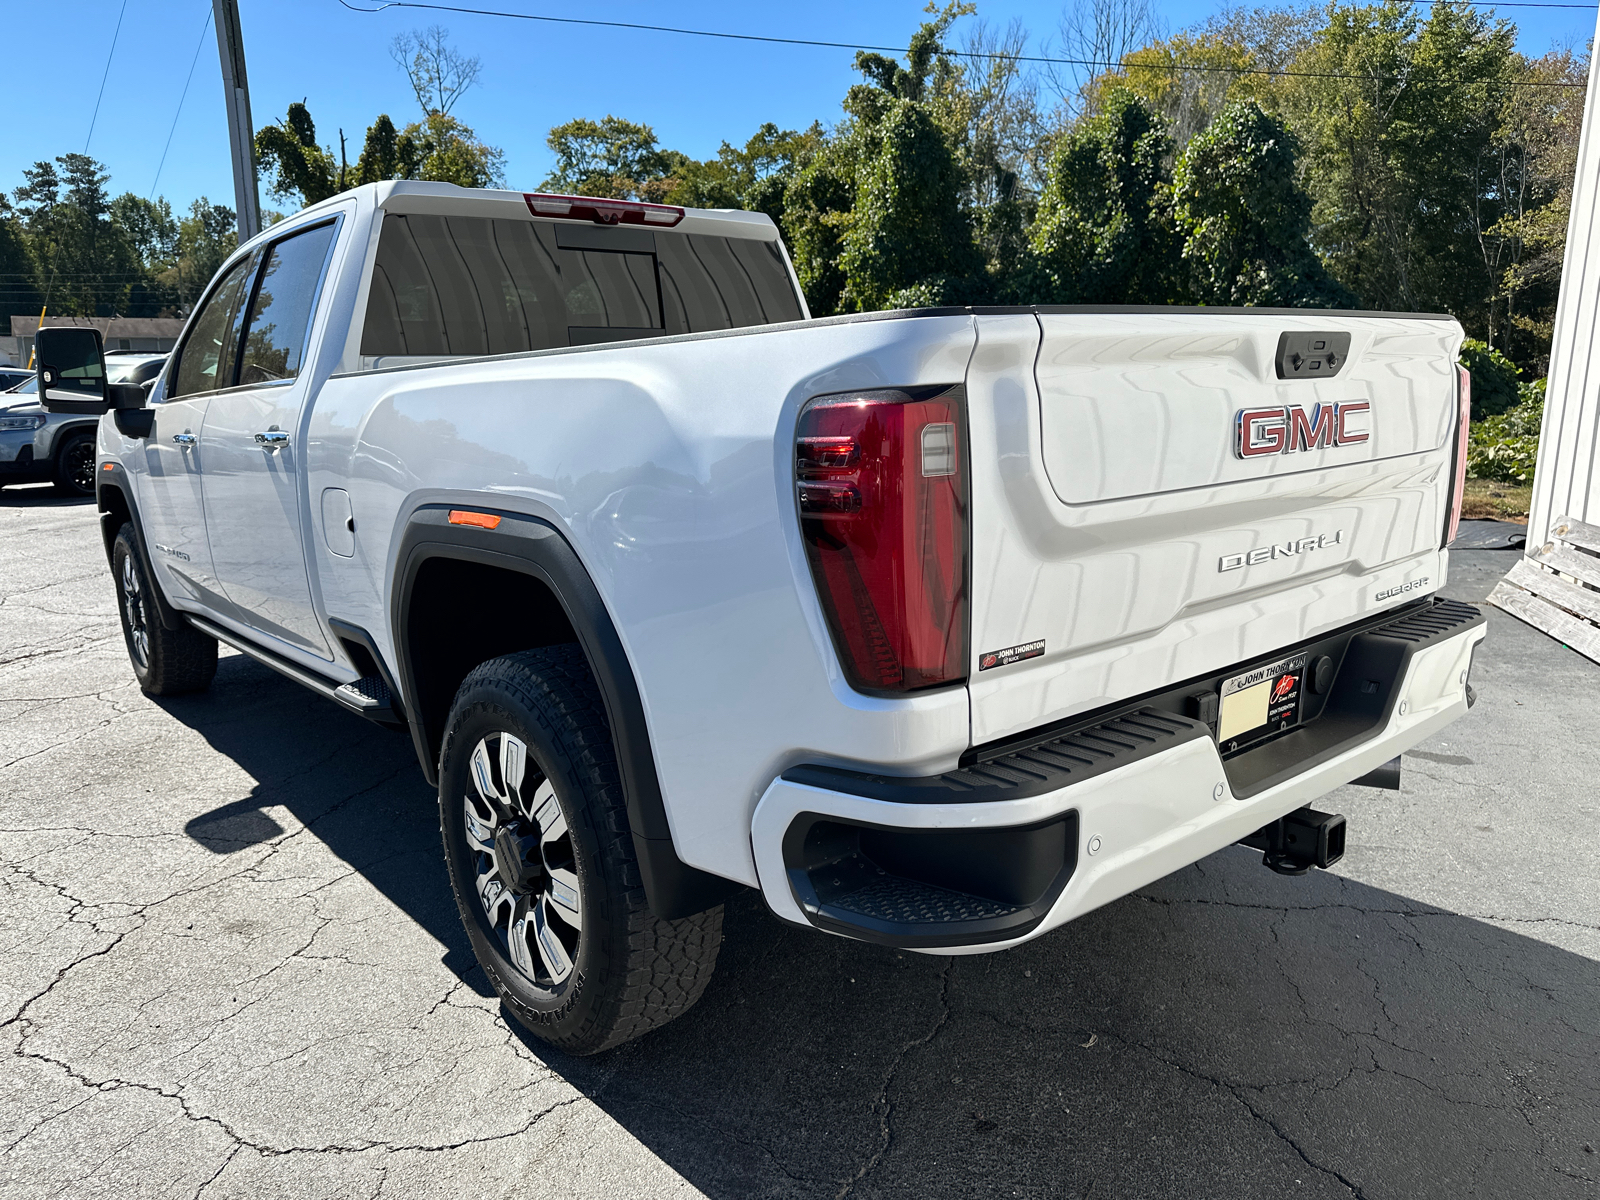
[1173,101,1355,307]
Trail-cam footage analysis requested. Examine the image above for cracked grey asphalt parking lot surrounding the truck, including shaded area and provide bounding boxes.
[0,488,1600,1200]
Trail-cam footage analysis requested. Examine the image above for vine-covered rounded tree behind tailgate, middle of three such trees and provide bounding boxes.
[1011,86,1182,304]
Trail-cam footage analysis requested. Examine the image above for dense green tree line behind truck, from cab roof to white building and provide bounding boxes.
[546,0,1586,371]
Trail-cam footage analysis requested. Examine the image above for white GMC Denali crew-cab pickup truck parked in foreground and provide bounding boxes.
[38,182,1483,1053]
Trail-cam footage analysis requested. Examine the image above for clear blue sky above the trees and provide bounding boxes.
[12,0,1595,219]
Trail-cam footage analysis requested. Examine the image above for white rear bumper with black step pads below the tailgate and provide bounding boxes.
[752,602,1485,954]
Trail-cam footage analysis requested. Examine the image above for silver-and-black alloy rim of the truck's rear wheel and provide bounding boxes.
[462,731,584,987]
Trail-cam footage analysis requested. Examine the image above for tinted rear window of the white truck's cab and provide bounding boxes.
[360,204,805,370]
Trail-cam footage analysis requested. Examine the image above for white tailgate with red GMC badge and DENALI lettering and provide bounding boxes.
[966,310,1461,744]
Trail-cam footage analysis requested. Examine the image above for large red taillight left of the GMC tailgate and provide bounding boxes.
[795,386,966,691]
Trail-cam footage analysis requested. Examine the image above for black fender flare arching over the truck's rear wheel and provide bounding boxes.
[390,504,741,920]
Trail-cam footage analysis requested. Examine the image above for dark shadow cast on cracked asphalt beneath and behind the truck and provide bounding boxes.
[162,656,1600,1200]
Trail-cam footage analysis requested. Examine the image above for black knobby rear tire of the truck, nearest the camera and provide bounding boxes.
[438,645,722,1054]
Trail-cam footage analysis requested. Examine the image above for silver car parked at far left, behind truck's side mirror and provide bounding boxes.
[0,350,166,496]
